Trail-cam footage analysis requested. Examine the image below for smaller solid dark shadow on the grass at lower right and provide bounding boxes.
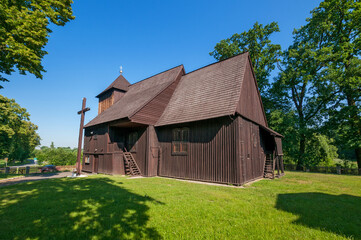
[276,192,361,239]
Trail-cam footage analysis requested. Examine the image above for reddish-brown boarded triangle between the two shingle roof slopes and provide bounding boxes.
[131,71,182,125]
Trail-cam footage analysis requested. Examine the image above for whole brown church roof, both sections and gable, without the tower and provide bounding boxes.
[85,53,274,128]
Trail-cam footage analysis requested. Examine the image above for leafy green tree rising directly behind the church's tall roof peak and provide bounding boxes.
[210,22,282,113]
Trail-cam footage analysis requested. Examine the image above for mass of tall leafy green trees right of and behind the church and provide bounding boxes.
[210,0,361,169]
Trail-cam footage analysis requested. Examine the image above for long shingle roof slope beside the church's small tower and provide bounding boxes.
[85,65,184,127]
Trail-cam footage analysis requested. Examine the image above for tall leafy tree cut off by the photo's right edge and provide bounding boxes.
[286,0,361,171]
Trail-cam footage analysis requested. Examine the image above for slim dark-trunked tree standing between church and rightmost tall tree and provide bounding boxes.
[271,43,336,167]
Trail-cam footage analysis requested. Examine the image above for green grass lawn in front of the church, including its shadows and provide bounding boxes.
[0,172,361,239]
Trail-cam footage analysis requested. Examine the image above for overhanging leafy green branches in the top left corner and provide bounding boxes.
[0,0,74,88]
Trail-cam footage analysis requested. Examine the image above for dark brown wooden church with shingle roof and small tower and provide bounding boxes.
[82,53,283,185]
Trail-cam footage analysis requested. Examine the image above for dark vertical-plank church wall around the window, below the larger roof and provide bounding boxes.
[157,117,238,184]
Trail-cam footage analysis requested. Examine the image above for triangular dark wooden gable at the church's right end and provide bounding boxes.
[236,59,267,126]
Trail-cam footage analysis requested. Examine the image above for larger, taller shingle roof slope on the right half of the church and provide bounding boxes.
[156,53,248,126]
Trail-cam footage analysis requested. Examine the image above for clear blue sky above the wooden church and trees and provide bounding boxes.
[0,0,320,147]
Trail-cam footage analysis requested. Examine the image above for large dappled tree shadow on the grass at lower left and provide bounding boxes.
[0,178,162,239]
